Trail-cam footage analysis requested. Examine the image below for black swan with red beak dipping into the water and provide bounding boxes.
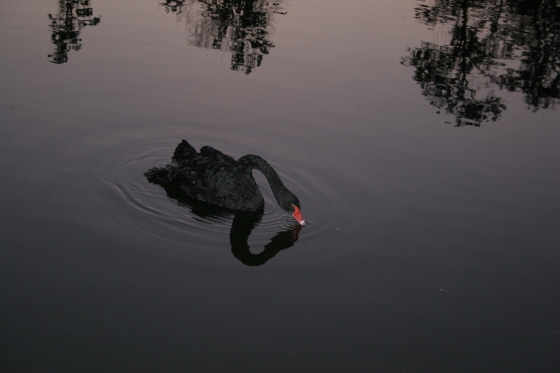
[144,140,305,225]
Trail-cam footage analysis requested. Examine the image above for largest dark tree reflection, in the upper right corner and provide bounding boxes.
[402,0,560,126]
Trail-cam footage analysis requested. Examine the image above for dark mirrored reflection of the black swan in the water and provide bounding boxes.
[147,180,302,266]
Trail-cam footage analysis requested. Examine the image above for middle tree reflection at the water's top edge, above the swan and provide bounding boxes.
[161,0,285,74]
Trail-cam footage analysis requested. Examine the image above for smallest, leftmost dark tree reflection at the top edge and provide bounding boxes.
[49,0,101,64]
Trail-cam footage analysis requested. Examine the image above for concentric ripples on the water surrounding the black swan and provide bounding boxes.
[88,137,340,258]
